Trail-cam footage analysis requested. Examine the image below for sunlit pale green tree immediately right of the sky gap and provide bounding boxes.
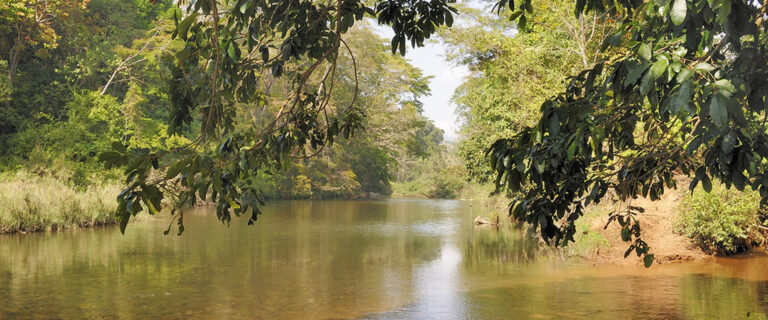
[441,1,617,182]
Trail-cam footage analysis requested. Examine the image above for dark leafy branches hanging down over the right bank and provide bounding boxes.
[489,0,768,266]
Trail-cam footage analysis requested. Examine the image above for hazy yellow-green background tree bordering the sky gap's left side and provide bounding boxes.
[252,25,442,198]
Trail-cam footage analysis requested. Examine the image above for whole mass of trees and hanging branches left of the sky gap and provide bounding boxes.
[0,0,450,235]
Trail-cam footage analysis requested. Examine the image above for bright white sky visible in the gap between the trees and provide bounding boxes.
[373,26,469,141]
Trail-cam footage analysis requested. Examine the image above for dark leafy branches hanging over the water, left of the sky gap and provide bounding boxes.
[79,0,462,231]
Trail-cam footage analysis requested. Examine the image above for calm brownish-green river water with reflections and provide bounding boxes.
[0,200,768,319]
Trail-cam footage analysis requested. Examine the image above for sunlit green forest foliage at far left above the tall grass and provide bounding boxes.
[0,0,177,185]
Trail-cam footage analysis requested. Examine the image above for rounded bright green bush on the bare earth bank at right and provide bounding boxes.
[676,185,764,255]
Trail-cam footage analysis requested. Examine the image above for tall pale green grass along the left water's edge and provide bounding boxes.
[0,172,120,233]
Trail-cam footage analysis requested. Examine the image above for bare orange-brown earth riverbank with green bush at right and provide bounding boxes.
[569,183,765,265]
